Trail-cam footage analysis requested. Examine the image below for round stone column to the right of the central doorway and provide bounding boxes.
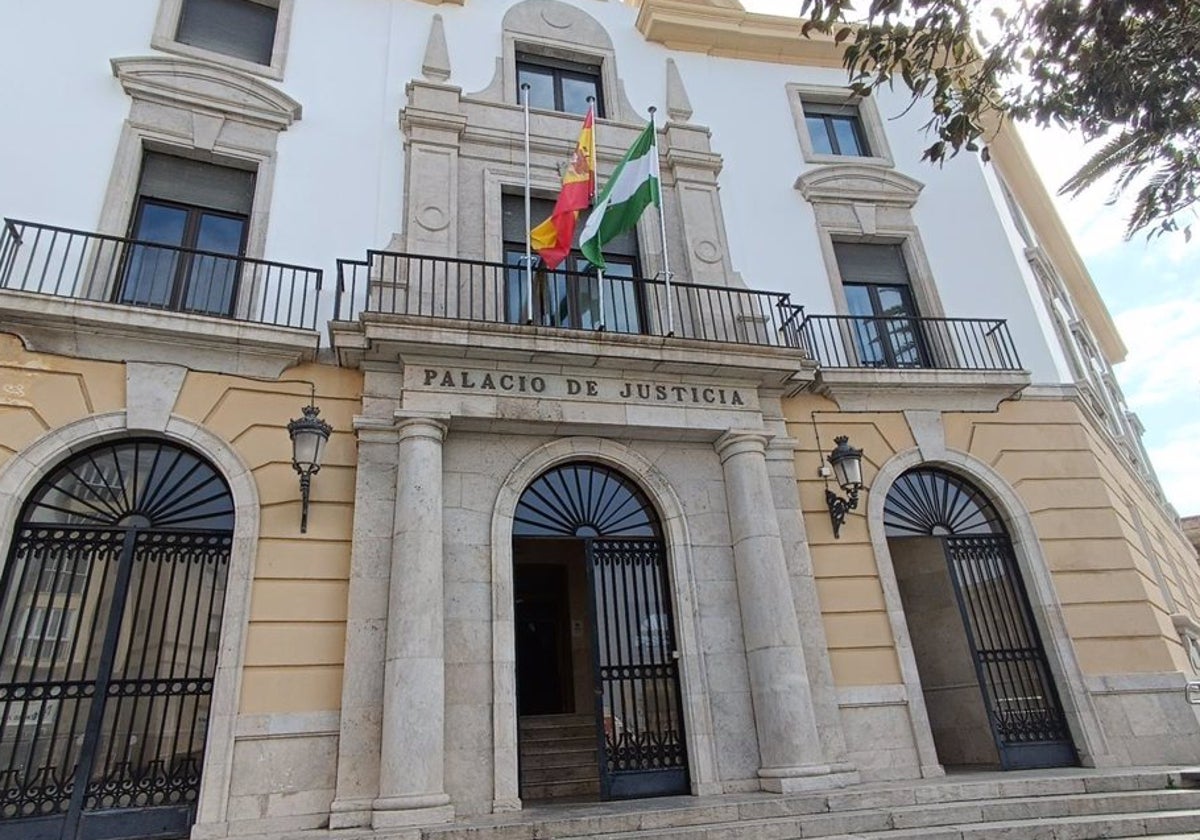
[715,431,841,793]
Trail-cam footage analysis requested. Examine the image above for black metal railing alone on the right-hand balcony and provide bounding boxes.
[802,316,1021,371]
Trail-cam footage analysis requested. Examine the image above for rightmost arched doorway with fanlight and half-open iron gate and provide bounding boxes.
[883,467,1079,769]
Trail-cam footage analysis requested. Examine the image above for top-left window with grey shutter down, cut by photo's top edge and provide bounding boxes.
[175,0,280,66]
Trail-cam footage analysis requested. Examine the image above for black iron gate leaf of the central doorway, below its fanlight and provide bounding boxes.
[587,539,689,799]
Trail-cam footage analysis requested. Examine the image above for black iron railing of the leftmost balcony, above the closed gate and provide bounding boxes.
[0,218,322,330]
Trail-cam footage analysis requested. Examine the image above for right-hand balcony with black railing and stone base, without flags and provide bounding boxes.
[800,316,1030,410]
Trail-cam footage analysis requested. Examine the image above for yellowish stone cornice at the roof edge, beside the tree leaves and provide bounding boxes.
[637,0,842,67]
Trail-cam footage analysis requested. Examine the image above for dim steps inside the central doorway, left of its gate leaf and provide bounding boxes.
[518,714,600,802]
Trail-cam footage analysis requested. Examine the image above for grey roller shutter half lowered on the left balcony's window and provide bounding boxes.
[138,151,254,216]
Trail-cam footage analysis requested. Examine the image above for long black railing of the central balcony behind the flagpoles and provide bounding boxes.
[334,251,804,349]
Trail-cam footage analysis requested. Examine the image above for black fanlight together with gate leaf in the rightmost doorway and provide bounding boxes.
[883,468,1078,769]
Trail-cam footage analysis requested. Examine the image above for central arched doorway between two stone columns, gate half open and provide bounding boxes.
[512,462,689,799]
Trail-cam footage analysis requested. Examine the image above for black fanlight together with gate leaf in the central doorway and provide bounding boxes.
[512,463,688,799]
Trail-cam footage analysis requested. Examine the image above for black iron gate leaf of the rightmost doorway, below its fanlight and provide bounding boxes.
[942,534,1078,769]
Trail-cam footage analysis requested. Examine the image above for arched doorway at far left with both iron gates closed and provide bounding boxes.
[0,439,234,840]
